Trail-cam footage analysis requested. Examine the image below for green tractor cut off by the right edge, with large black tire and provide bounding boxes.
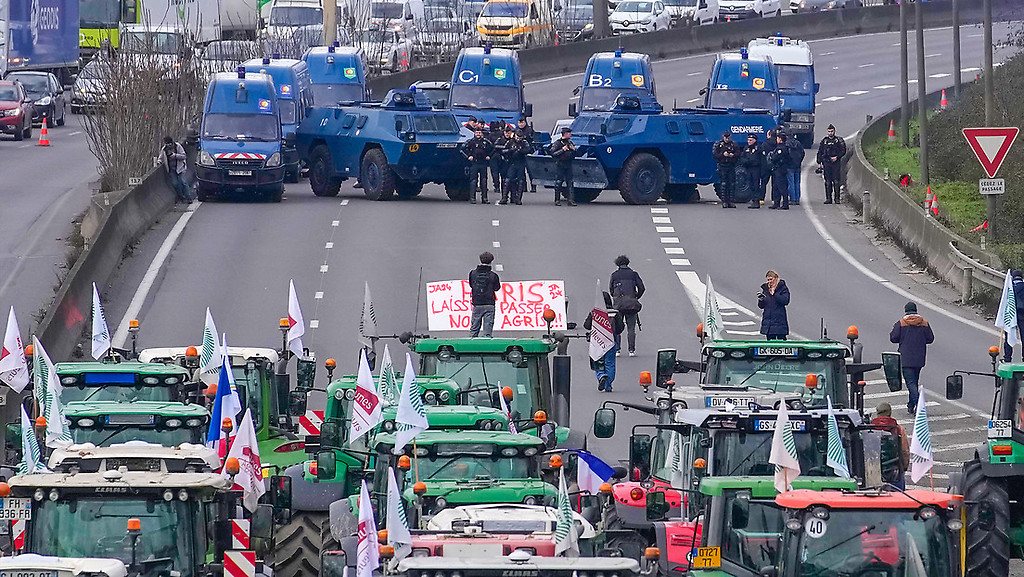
[946,346,1024,577]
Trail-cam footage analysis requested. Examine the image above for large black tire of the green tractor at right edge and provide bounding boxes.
[959,457,1010,577]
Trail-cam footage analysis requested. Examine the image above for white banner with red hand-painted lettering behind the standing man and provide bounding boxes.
[427,281,565,331]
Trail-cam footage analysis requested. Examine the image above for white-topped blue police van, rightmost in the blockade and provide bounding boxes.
[746,34,820,148]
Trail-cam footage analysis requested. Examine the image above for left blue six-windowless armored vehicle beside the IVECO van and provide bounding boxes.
[296,89,472,201]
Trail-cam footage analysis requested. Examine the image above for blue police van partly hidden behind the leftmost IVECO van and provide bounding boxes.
[244,54,313,182]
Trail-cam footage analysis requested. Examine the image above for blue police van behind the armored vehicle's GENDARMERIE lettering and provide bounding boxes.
[700,48,788,124]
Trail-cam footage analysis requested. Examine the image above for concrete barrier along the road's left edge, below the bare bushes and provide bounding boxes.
[36,167,174,362]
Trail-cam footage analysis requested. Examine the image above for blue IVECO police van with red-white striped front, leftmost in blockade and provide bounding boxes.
[196,68,285,202]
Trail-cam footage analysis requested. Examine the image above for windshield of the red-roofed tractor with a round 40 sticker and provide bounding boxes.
[783,507,958,577]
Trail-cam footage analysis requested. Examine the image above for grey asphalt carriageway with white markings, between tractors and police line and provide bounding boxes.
[18,27,1024,486]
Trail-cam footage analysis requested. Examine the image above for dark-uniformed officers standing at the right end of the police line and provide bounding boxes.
[712,124,846,210]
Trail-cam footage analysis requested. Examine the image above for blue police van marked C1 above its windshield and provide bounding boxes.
[449,46,534,123]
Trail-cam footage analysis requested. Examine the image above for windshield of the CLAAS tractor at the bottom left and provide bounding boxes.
[28,497,199,577]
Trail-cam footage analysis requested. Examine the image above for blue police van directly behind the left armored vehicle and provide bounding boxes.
[302,42,370,107]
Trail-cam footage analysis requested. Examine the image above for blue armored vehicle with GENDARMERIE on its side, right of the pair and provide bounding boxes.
[526,94,776,204]
